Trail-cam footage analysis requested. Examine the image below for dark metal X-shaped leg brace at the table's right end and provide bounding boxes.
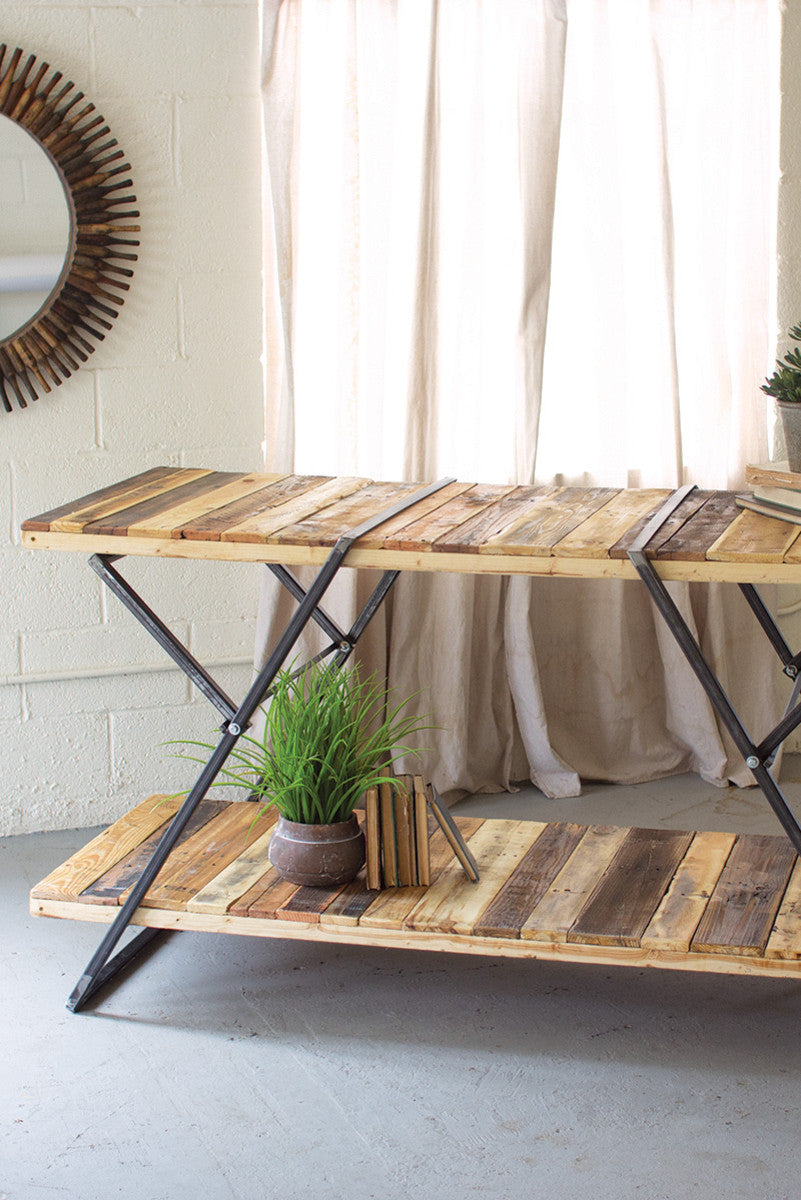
[628,485,801,853]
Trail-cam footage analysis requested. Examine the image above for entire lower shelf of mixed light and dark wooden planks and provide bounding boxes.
[31,796,801,977]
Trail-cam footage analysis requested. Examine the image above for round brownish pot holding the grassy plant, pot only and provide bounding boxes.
[270,815,365,888]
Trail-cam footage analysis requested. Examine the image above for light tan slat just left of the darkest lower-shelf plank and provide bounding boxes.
[520,826,628,942]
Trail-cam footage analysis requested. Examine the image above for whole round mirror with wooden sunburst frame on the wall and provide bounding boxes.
[0,44,139,413]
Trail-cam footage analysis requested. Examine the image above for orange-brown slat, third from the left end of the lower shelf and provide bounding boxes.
[141,800,272,910]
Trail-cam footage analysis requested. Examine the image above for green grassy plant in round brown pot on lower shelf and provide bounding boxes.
[172,664,428,887]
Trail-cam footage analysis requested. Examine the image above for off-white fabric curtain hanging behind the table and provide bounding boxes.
[257,0,779,796]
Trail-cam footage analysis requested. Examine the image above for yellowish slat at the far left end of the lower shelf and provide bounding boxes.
[31,796,180,900]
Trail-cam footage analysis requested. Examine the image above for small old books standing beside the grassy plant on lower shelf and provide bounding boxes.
[365,775,478,890]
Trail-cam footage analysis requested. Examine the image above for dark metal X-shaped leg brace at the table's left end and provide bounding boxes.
[67,478,453,1013]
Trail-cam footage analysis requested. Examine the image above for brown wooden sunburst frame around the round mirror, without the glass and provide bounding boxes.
[0,43,139,413]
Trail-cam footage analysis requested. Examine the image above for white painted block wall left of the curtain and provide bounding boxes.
[0,0,264,833]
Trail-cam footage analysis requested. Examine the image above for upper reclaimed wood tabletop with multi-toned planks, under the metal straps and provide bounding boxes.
[22,467,801,582]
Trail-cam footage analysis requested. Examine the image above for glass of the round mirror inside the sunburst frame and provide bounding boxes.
[0,115,72,342]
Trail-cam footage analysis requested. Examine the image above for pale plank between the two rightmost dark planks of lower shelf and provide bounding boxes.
[640,833,737,952]
